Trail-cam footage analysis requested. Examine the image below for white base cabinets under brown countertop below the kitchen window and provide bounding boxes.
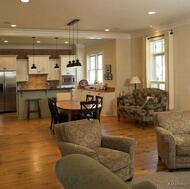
[77,89,115,116]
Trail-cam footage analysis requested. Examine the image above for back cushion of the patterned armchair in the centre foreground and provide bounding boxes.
[60,119,102,148]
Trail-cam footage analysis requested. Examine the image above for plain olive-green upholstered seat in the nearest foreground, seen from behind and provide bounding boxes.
[55,154,157,189]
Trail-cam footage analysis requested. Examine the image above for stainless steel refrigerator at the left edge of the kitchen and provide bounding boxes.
[0,71,16,112]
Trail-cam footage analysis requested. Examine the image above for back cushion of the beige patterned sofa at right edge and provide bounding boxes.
[157,111,190,134]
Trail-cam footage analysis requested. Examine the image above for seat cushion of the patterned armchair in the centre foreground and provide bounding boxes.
[93,147,131,172]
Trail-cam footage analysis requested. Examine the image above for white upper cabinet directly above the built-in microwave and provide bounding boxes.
[60,55,76,75]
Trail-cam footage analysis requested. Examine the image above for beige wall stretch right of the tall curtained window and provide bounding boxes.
[173,25,190,111]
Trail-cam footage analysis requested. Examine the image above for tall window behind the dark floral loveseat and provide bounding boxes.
[147,38,166,90]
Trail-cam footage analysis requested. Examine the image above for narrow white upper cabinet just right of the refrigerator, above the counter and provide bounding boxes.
[16,59,28,82]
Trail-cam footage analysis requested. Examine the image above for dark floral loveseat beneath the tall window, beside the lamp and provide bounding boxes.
[117,88,168,123]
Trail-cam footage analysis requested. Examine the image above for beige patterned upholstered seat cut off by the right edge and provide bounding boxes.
[154,111,190,171]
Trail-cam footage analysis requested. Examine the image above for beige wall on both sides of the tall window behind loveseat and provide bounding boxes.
[131,25,190,111]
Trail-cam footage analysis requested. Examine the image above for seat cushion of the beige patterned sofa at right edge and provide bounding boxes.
[174,134,190,156]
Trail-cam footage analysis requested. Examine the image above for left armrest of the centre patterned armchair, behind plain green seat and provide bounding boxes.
[58,142,99,161]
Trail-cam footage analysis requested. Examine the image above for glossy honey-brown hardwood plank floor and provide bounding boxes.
[0,113,166,189]
